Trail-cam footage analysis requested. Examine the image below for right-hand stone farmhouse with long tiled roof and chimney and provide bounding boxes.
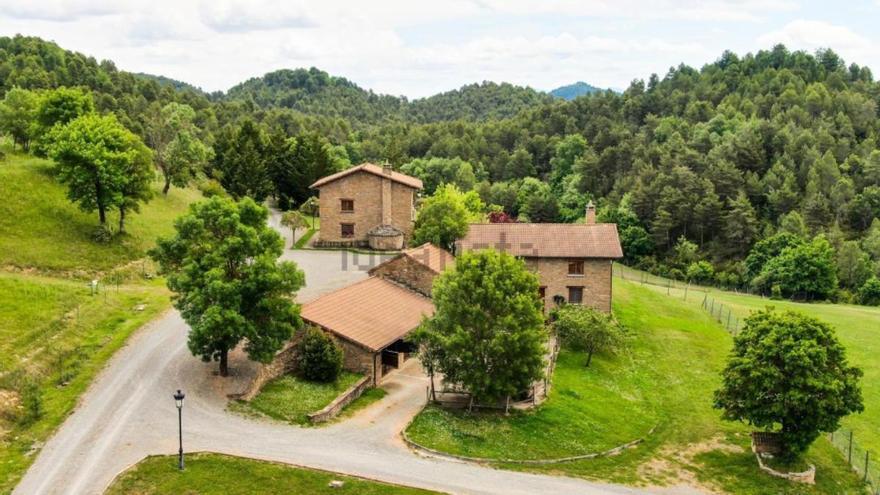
[456,203,623,312]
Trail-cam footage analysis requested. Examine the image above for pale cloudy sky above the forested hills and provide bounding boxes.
[0,0,880,98]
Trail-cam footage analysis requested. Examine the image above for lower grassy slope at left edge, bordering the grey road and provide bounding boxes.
[0,272,169,493]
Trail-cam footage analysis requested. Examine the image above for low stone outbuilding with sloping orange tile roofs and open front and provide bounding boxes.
[301,244,454,386]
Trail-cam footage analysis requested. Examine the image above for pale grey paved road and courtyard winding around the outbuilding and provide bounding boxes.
[14,225,648,495]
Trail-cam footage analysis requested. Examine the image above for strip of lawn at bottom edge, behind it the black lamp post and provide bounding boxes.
[106,454,437,495]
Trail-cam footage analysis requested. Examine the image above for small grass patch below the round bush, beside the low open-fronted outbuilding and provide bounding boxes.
[231,371,368,425]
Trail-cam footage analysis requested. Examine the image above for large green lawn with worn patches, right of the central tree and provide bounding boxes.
[407,280,861,494]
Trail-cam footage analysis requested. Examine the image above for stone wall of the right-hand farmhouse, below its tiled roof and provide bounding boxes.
[525,258,612,313]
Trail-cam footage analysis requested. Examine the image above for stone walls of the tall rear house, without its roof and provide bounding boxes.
[316,171,416,246]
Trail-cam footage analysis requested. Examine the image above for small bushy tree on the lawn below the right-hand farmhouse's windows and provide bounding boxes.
[553,304,624,367]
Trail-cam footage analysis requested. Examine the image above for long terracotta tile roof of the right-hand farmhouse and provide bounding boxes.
[456,223,623,258]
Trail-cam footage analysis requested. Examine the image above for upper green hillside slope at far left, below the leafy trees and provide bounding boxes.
[0,148,200,276]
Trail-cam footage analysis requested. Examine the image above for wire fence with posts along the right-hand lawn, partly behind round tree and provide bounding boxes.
[615,263,880,495]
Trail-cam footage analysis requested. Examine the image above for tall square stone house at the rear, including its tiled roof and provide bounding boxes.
[311,163,422,250]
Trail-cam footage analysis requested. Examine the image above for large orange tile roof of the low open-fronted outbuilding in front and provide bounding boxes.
[301,277,434,351]
